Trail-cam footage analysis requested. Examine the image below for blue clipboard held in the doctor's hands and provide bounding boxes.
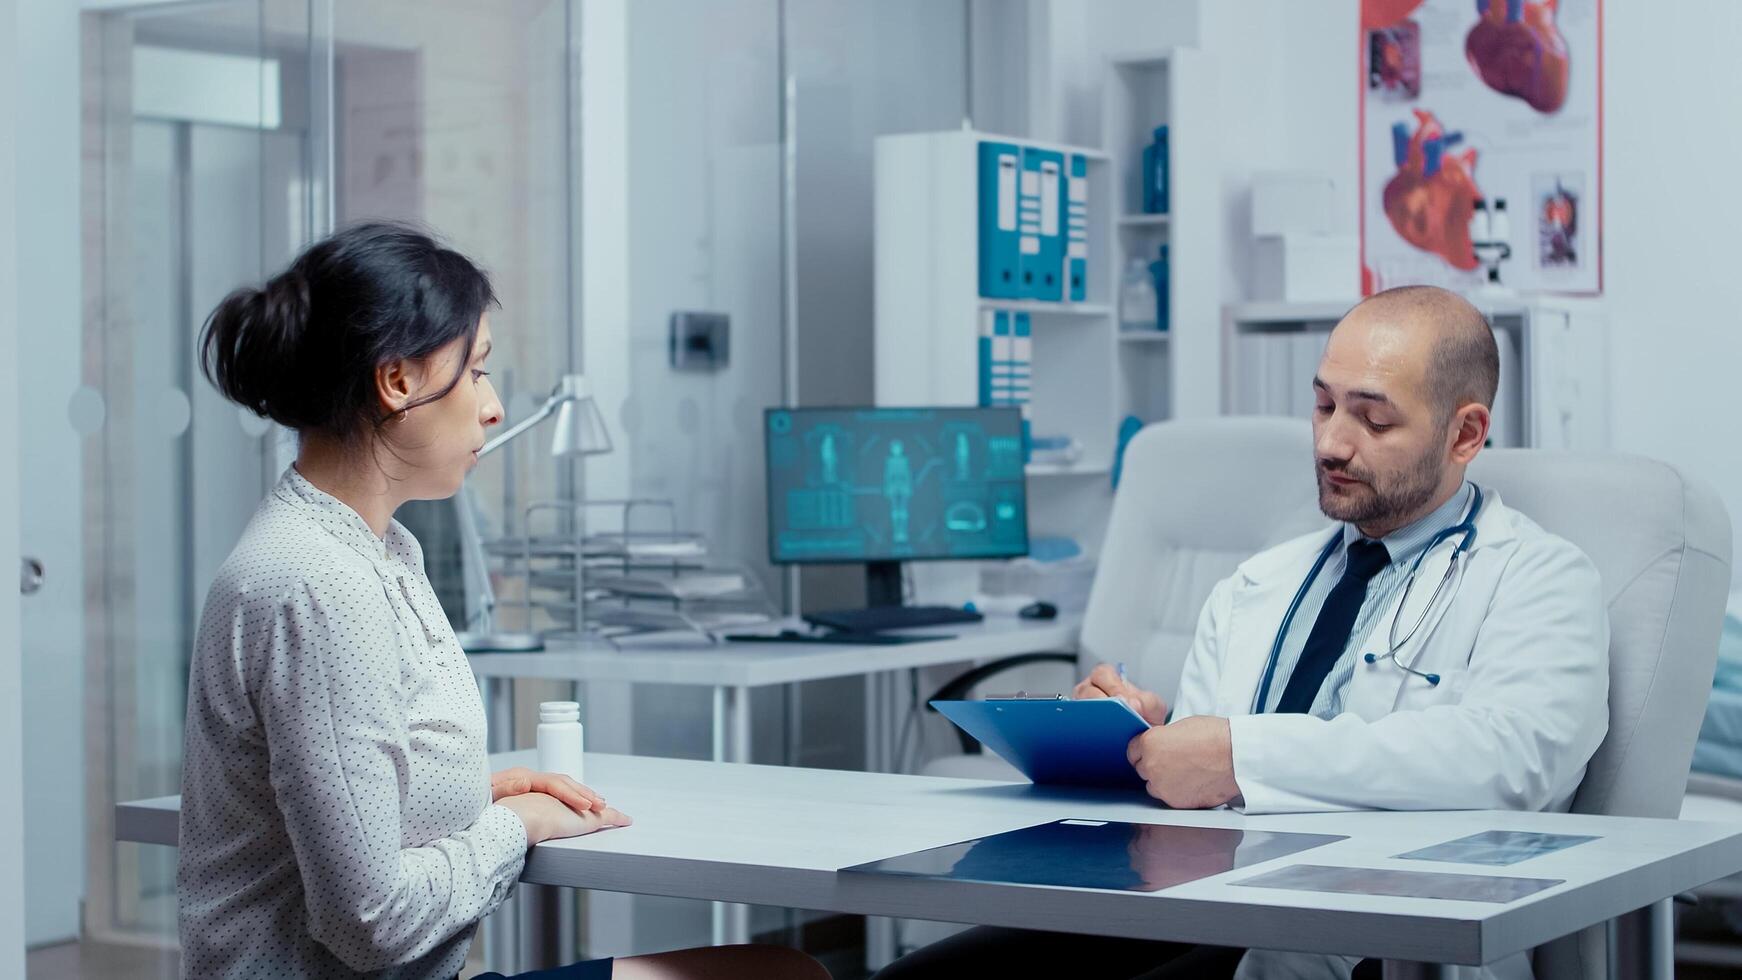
[932,698,1150,787]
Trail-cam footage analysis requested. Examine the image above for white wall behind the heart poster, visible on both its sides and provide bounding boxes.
[1197,0,1742,577]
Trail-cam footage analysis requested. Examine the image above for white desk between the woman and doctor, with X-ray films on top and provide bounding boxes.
[115,752,1742,977]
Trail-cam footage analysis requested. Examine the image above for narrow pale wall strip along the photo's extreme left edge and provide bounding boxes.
[0,0,24,977]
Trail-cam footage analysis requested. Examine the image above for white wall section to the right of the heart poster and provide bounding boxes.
[1603,0,1742,567]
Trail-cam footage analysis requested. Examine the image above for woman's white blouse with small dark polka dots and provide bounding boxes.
[176,467,526,978]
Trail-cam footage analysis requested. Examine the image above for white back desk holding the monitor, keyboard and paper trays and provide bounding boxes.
[467,616,1082,971]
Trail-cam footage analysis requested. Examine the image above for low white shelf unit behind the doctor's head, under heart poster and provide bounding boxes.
[1223,296,1610,451]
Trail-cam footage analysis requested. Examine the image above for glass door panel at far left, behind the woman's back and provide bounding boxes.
[70,2,314,970]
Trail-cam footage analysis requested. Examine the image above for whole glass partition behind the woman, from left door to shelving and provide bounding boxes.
[70,0,970,967]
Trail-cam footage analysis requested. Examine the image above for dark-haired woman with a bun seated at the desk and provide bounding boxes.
[178,225,826,980]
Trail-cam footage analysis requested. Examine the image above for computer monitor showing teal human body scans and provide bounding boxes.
[763,407,1028,606]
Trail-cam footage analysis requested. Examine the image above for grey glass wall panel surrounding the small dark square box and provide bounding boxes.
[616,0,782,616]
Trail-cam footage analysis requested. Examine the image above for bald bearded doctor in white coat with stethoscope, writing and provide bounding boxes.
[883,287,1610,980]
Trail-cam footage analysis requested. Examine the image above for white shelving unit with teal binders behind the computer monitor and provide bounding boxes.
[874,50,1221,601]
